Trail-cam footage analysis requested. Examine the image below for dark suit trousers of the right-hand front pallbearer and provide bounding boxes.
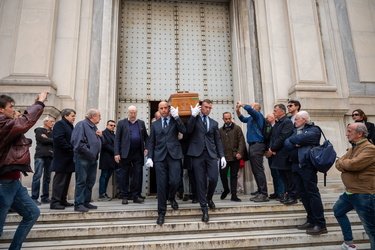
[192,150,219,213]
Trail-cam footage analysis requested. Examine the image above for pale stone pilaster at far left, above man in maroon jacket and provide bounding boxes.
[0,0,59,117]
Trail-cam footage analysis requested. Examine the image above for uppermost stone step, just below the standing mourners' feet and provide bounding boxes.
[6,199,334,225]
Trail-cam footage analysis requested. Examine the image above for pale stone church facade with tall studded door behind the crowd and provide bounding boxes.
[0,0,375,195]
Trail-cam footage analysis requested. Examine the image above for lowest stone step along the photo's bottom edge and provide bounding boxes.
[0,226,370,250]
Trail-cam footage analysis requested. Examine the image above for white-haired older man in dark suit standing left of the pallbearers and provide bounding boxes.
[114,106,148,205]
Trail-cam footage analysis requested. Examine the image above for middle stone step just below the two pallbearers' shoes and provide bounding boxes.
[0,212,360,242]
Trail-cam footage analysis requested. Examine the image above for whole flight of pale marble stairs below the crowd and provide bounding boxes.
[0,188,370,250]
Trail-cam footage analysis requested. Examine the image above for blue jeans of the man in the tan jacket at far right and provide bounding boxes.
[333,193,375,249]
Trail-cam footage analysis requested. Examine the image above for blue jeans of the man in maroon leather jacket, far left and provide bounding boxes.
[0,179,40,249]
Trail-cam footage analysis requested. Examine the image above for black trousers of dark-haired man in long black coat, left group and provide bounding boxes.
[50,172,72,207]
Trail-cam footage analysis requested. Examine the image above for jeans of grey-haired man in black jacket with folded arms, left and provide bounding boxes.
[31,157,52,201]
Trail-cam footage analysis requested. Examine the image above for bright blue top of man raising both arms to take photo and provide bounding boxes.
[239,105,264,142]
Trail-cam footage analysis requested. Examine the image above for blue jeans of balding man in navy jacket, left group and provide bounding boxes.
[73,155,97,207]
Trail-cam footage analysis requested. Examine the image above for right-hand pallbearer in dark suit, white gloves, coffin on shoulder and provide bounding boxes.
[186,99,227,222]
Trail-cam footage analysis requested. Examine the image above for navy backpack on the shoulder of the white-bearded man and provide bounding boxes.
[310,126,337,186]
